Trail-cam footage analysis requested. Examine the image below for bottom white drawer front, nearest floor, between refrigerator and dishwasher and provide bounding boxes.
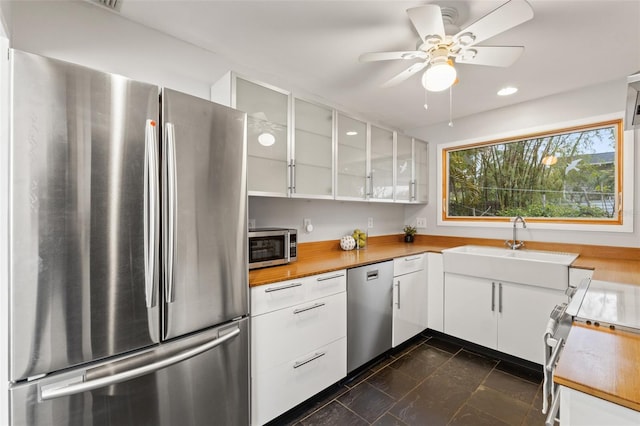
[251,338,347,425]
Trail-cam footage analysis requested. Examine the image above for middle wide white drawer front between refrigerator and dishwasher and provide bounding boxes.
[251,292,347,373]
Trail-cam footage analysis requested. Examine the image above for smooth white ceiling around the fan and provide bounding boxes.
[115,0,640,130]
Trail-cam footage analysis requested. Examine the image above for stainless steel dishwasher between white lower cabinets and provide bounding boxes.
[347,261,393,372]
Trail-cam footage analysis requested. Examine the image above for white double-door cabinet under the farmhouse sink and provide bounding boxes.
[444,273,567,364]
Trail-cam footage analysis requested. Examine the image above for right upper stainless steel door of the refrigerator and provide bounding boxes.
[162,89,249,339]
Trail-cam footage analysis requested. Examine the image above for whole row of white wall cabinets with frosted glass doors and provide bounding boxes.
[211,72,428,203]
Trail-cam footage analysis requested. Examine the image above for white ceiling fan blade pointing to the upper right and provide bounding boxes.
[454,0,533,46]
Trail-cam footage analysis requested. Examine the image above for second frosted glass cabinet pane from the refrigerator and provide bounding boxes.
[293,99,333,197]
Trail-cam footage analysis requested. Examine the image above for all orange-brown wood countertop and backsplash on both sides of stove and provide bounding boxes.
[249,235,640,411]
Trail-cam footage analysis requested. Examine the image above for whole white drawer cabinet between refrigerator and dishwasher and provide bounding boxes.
[251,270,347,425]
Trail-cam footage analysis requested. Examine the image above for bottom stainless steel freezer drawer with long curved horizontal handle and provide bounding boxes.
[9,319,249,426]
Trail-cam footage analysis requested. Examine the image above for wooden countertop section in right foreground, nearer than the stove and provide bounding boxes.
[554,324,640,411]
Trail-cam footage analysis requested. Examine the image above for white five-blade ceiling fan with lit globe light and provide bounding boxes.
[360,0,533,92]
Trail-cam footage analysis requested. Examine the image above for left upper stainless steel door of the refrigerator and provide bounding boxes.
[9,51,160,381]
